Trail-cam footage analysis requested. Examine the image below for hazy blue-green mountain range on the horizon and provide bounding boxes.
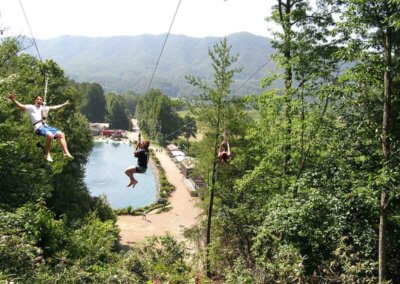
[26,32,275,97]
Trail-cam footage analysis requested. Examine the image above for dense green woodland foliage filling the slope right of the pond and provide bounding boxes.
[177,1,400,283]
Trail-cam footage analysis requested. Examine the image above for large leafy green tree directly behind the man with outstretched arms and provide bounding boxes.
[0,39,92,218]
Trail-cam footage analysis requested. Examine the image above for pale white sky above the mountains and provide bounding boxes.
[0,0,275,39]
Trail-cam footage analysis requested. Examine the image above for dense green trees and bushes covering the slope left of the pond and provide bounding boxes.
[0,39,197,283]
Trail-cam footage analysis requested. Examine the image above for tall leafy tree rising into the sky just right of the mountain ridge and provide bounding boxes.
[269,0,335,178]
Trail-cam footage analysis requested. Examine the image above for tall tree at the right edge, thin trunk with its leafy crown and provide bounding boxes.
[329,0,400,283]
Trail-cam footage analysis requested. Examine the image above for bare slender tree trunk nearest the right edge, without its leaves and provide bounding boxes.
[379,28,392,283]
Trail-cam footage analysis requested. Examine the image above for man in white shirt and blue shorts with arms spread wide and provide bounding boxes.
[8,94,73,162]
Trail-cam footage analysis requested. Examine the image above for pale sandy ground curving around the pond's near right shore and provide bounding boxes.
[117,121,201,245]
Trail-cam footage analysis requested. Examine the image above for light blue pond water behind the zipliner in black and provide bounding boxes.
[85,141,157,209]
